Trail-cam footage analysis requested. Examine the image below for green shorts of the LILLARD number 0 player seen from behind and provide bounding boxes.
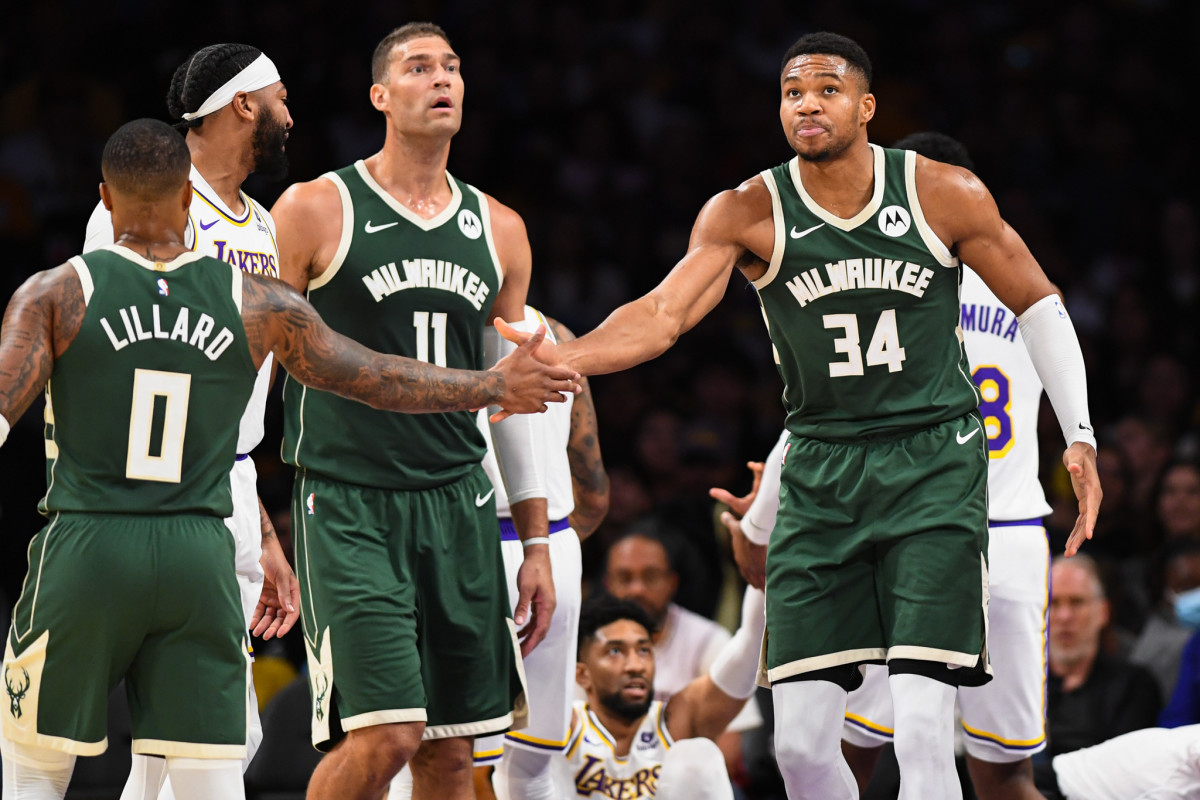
[0,513,250,759]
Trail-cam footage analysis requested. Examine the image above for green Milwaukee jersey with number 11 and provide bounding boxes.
[283,161,502,489]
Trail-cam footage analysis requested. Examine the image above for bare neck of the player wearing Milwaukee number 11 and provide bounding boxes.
[366,128,454,218]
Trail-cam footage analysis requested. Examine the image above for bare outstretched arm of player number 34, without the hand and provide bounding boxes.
[557,183,774,375]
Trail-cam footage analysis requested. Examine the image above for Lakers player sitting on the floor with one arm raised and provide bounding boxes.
[564,588,766,800]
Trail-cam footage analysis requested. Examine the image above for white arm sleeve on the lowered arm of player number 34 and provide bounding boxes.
[1016,295,1096,449]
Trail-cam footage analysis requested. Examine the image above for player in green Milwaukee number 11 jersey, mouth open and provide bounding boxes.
[272,23,554,800]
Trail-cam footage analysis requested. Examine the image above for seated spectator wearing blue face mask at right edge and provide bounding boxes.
[1129,540,1200,697]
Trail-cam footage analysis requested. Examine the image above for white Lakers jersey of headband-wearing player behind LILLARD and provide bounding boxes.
[83,164,280,453]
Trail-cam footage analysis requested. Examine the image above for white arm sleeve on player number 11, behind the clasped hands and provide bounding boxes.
[484,320,550,507]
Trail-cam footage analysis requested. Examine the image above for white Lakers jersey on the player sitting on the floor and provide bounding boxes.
[566,700,674,800]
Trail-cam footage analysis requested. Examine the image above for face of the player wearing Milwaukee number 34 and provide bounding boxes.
[779,54,875,162]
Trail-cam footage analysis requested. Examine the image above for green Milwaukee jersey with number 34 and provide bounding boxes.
[754,145,979,441]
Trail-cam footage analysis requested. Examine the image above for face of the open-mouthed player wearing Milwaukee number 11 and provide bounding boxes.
[371,36,463,136]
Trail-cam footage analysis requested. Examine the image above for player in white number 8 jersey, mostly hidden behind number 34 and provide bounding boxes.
[842,133,1050,800]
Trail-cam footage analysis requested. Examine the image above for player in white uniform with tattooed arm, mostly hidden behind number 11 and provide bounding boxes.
[388,306,608,800]
